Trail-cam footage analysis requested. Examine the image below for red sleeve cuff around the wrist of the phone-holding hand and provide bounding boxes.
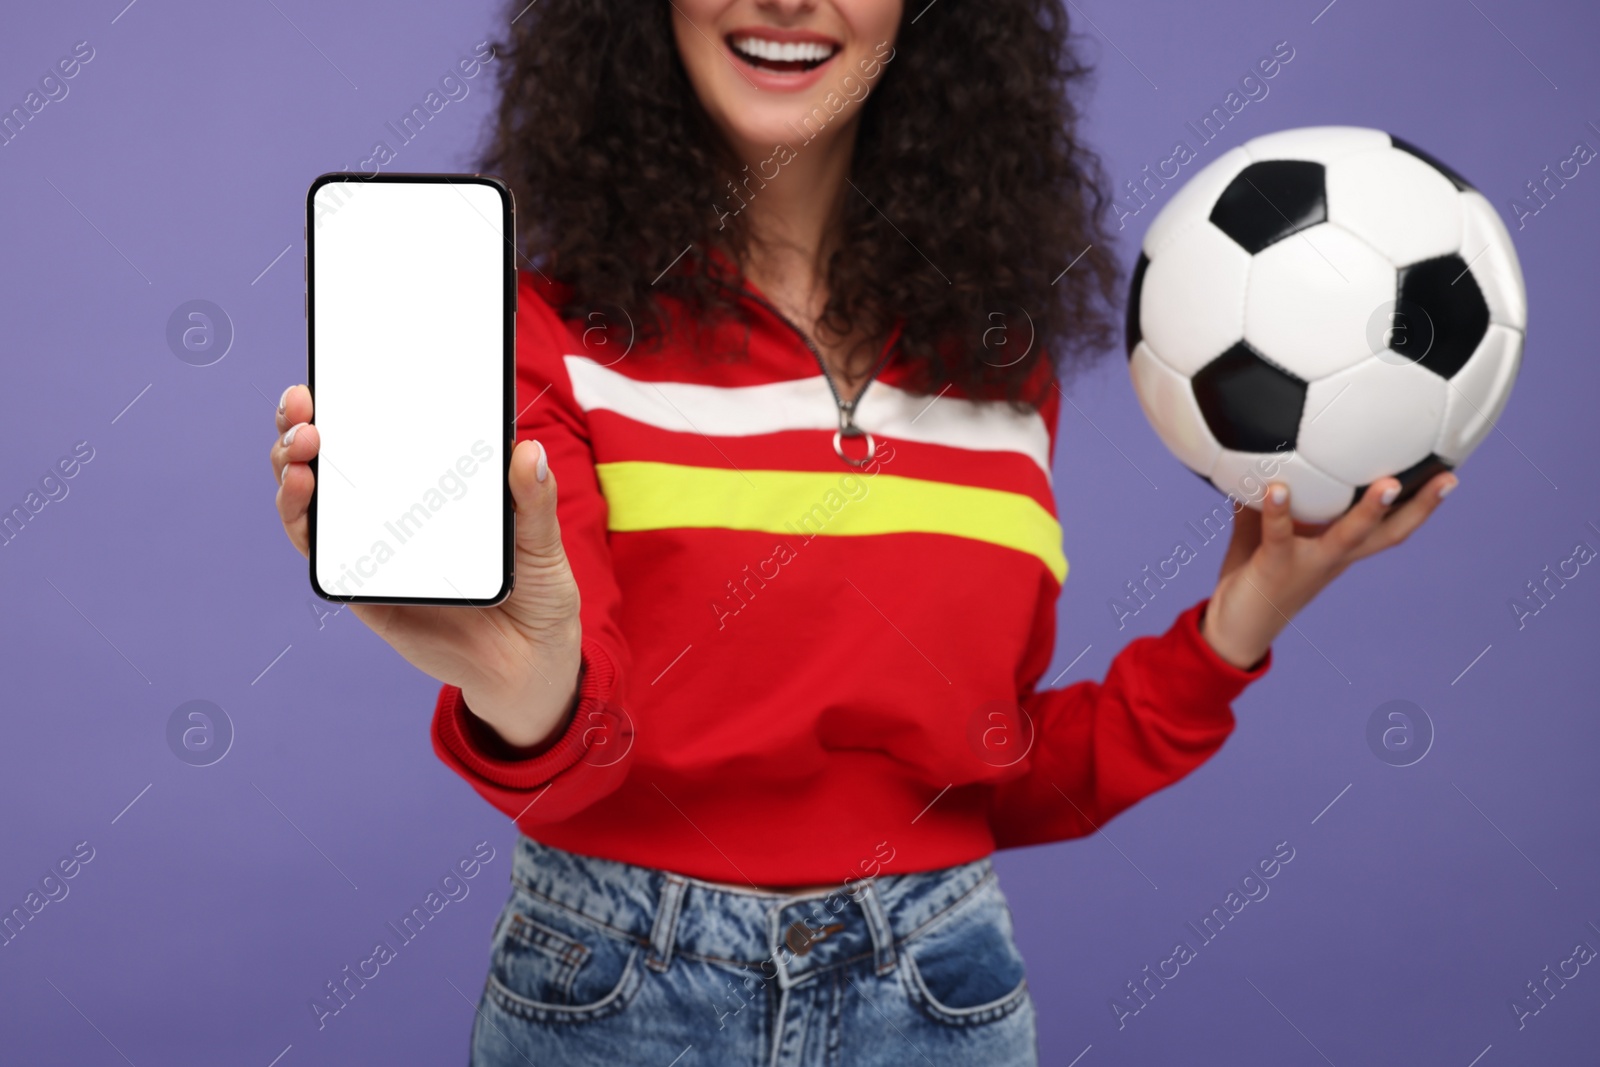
[434,638,616,790]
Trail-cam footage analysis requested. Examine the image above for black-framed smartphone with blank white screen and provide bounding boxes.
[306,173,517,606]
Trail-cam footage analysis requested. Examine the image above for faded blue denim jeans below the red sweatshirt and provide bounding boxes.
[472,837,1038,1067]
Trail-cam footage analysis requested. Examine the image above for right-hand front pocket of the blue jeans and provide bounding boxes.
[901,881,1027,1025]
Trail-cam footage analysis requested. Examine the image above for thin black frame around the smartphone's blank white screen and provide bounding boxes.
[304,171,517,608]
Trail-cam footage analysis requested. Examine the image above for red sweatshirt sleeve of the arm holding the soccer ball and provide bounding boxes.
[989,379,1272,848]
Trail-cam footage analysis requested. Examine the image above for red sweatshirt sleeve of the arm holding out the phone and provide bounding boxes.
[432,274,632,829]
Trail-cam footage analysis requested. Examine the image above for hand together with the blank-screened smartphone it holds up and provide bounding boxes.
[272,174,581,749]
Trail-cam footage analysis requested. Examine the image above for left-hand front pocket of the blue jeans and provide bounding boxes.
[488,889,645,1022]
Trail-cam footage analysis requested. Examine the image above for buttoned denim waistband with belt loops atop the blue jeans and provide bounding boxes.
[512,835,995,989]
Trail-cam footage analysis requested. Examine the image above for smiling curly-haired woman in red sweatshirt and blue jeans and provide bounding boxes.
[262,0,1454,1065]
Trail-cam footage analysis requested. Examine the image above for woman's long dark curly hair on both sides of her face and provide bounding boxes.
[480,0,1120,405]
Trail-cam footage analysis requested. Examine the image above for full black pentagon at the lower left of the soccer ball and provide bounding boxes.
[1190,341,1306,453]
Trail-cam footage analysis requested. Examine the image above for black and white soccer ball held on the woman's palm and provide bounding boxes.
[1128,126,1528,523]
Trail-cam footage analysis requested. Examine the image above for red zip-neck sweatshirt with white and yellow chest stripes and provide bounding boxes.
[434,274,1270,886]
